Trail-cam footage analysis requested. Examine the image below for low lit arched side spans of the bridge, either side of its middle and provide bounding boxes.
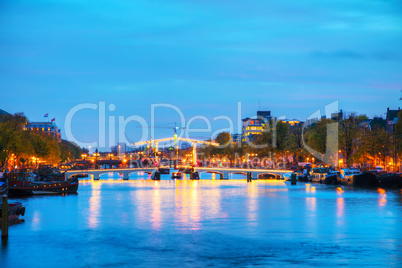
[65,167,293,180]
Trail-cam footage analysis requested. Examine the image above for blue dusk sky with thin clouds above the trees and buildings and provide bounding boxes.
[0,0,402,150]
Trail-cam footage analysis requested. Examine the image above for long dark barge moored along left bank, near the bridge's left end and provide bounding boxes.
[7,172,79,195]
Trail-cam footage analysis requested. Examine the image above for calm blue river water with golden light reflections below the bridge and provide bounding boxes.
[0,174,402,268]
